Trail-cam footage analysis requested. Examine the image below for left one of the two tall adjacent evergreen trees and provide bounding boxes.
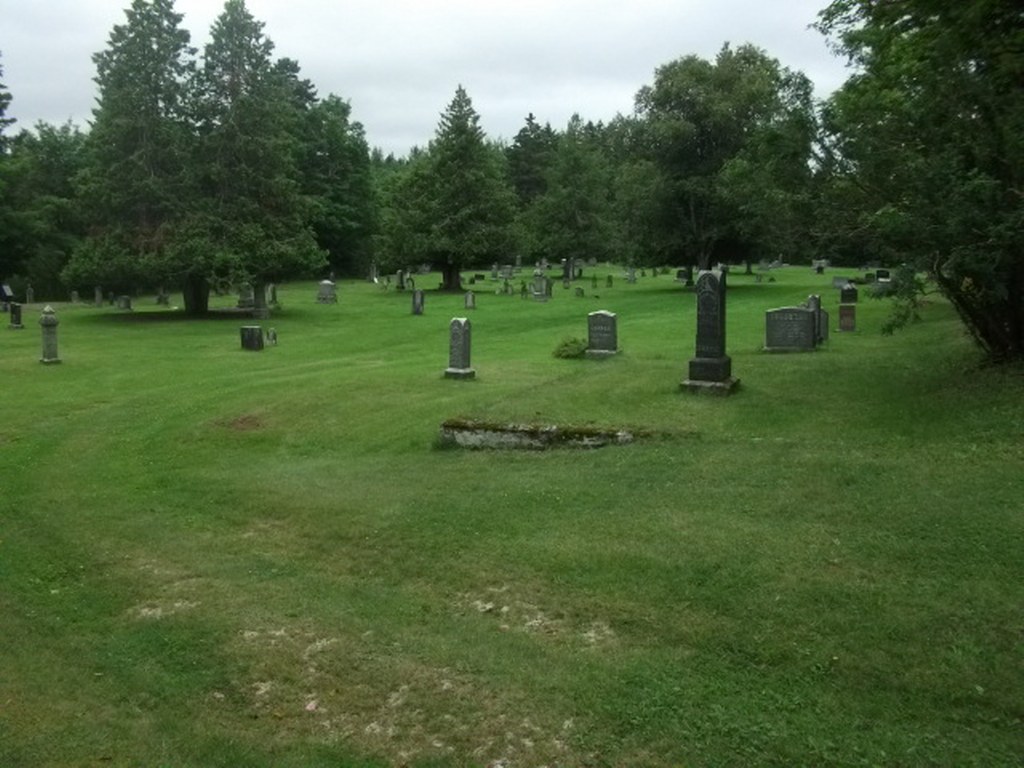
[65,0,195,289]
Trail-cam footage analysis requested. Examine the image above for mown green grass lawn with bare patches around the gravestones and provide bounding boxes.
[0,267,1024,768]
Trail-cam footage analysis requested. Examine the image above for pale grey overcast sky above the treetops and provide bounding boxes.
[0,0,847,155]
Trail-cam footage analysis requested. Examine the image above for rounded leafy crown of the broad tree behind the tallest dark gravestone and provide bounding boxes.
[636,45,810,268]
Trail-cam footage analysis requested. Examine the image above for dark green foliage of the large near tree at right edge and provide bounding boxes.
[819,0,1024,360]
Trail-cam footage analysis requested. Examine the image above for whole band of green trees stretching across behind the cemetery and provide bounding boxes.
[0,0,1024,359]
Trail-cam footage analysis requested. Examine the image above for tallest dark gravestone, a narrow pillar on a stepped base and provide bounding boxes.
[681,269,739,394]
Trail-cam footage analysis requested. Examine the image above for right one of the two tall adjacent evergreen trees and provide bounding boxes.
[174,0,325,311]
